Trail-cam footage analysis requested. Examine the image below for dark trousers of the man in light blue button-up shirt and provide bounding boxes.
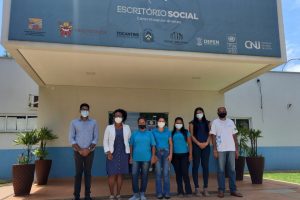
[74,151,94,199]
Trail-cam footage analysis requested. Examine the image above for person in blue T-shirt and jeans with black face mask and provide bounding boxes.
[129,117,156,200]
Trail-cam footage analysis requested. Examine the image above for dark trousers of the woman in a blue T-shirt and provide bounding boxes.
[172,153,192,194]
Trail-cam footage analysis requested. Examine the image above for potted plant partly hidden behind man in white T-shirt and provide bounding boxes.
[235,127,249,181]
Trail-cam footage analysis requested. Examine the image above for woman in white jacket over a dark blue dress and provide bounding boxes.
[103,109,131,200]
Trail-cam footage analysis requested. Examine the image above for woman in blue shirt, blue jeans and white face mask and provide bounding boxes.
[152,117,173,199]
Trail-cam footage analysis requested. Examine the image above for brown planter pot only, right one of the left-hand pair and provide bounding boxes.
[35,160,52,185]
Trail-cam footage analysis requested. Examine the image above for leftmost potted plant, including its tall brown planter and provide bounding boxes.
[12,130,39,196]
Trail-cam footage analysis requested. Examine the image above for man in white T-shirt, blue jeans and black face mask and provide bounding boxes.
[210,107,243,198]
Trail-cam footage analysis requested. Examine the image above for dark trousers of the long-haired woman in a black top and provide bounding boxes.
[192,144,210,188]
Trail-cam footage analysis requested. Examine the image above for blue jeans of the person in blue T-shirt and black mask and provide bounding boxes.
[132,161,150,193]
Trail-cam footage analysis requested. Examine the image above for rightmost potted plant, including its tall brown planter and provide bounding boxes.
[246,129,265,184]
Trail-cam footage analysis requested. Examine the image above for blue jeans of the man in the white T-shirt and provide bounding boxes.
[218,151,236,192]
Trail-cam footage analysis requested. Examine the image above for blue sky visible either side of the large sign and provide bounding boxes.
[0,0,300,72]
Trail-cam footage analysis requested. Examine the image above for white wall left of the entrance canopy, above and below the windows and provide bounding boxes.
[0,58,39,149]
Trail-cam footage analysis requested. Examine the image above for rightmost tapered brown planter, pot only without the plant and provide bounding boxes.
[246,157,265,184]
